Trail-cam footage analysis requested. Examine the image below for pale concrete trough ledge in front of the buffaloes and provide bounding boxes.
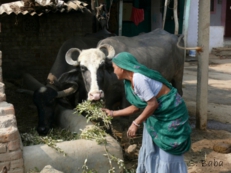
[23,136,123,173]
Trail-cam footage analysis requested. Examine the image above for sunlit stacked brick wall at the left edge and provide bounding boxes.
[0,52,24,173]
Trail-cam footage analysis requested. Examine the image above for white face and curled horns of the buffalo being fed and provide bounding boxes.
[66,44,115,100]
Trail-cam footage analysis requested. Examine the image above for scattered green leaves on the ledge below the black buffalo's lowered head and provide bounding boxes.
[21,128,79,156]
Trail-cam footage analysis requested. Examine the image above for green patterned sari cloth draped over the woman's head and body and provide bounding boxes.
[112,52,191,155]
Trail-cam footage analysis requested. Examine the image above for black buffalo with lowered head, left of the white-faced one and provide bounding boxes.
[21,29,112,135]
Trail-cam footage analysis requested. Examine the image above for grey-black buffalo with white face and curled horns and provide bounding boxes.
[66,29,184,109]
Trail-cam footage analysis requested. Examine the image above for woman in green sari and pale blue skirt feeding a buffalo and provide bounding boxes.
[103,52,191,173]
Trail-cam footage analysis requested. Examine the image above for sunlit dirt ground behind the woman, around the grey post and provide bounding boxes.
[180,55,231,173]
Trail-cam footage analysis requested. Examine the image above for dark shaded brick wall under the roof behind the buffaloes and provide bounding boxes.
[0,11,93,83]
